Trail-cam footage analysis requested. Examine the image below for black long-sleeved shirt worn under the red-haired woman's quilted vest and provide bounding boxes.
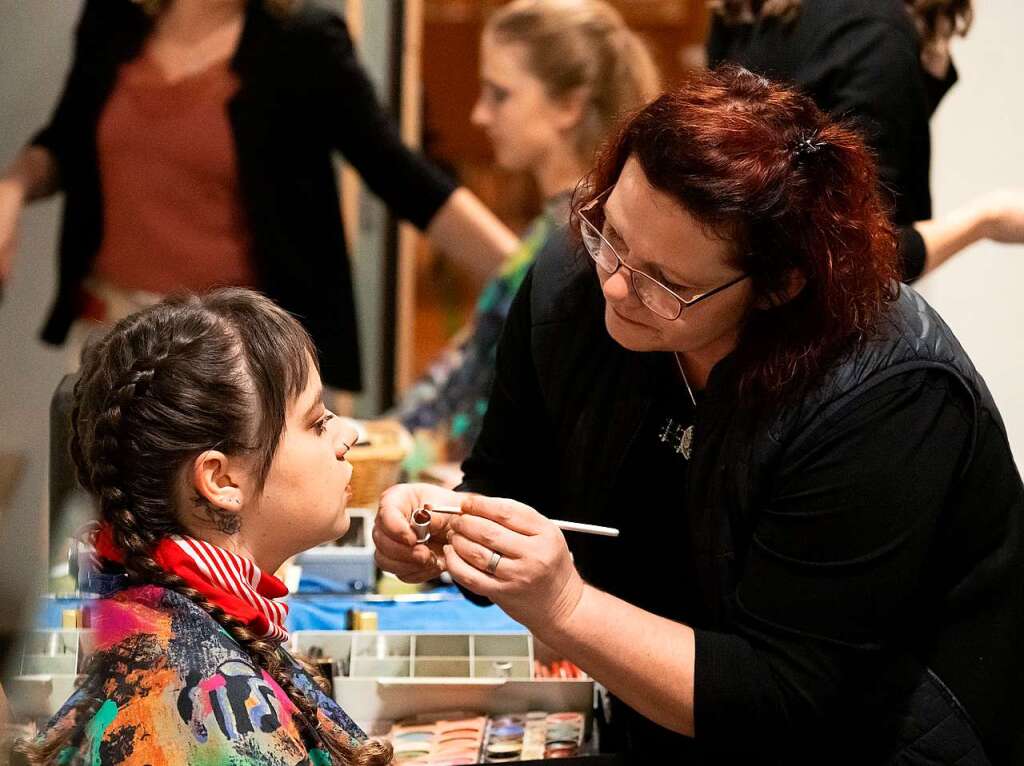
[463,259,1021,764]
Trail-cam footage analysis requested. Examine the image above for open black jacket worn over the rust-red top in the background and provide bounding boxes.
[33,0,455,390]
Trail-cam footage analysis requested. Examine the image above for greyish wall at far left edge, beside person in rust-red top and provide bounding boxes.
[0,0,81,588]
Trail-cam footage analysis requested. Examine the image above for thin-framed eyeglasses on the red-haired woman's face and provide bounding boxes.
[579,186,750,322]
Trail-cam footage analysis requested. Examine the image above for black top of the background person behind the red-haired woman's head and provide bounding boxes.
[707,0,956,282]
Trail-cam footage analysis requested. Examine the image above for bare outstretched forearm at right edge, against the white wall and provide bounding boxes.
[913,189,1024,274]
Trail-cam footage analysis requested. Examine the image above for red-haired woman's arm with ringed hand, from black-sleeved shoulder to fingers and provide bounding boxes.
[444,372,972,755]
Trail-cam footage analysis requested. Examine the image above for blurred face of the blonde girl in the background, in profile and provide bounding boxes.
[471,34,579,172]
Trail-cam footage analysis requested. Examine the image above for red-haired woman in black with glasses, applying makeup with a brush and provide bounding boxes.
[374,69,1024,766]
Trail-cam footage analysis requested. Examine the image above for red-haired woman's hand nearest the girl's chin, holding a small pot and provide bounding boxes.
[373,484,466,583]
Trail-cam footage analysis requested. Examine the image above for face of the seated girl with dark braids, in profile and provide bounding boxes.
[242,364,356,560]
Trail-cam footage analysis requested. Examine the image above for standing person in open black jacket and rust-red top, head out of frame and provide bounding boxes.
[0,0,517,390]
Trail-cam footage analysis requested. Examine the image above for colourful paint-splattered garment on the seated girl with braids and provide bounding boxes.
[38,586,365,766]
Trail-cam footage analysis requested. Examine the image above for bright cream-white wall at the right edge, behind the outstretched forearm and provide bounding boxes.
[919,0,1024,466]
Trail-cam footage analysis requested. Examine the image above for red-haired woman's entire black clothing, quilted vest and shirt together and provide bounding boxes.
[463,245,1024,766]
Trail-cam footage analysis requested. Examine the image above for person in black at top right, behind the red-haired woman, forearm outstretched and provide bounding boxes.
[707,0,1024,282]
